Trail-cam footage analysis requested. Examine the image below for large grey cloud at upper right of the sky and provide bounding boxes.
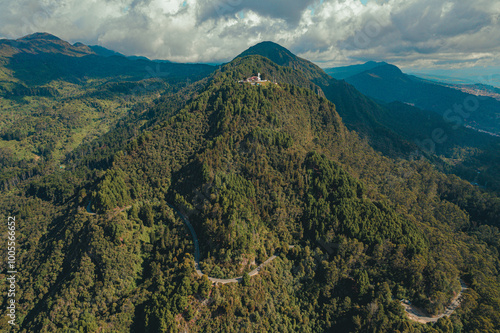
[339,0,492,54]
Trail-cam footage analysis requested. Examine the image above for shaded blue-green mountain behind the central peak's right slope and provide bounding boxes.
[327,62,500,192]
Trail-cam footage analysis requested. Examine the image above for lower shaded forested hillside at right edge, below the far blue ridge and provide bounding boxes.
[379,102,500,189]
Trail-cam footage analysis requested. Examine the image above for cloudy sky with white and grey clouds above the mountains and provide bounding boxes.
[0,0,500,79]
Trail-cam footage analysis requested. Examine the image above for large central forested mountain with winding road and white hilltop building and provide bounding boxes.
[0,36,500,332]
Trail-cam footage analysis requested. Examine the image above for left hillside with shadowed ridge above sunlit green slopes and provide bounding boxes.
[0,33,214,193]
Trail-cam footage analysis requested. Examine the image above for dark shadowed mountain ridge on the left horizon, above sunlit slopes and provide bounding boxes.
[0,33,215,87]
